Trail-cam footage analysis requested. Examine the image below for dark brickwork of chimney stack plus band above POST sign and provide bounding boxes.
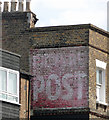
[2,12,89,72]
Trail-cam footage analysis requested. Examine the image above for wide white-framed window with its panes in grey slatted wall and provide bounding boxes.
[0,67,19,103]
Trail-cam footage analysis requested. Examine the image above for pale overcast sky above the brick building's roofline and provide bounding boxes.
[2,0,109,30]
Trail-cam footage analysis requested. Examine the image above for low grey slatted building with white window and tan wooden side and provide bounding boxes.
[0,49,31,120]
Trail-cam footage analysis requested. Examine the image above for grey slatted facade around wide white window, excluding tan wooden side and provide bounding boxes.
[0,50,20,119]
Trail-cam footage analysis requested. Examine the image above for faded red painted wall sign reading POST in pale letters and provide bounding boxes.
[30,47,88,109]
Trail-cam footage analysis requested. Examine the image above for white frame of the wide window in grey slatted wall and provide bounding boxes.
[0,67,19,104]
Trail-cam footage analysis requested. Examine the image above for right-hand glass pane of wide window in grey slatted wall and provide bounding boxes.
[8,73,17,94]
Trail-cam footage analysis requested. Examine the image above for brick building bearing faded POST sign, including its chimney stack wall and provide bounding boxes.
[2,0,109,120]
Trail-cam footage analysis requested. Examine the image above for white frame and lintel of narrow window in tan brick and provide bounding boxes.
[96,59,107,104]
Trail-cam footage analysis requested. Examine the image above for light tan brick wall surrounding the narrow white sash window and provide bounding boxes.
[89,30,109,118]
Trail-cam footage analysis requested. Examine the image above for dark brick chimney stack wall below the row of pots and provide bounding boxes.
[2,12,37,71]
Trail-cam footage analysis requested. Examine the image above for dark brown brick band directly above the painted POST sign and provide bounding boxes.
[29,25,88,48]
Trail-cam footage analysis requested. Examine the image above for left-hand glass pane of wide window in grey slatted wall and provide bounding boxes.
[0,70,7,91]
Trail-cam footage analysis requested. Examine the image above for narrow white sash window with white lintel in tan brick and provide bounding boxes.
[96,60,106,103]
